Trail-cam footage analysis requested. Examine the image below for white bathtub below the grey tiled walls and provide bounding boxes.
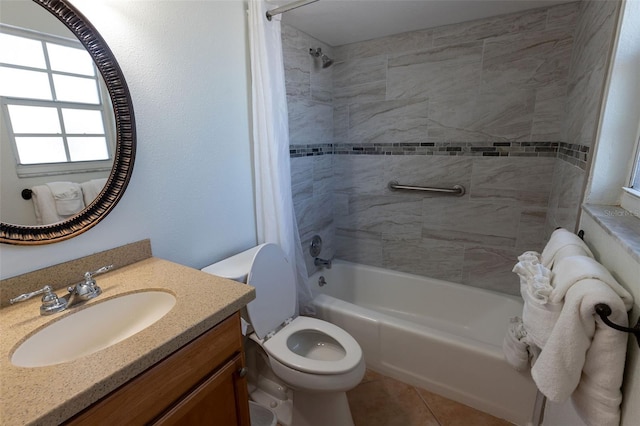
[310,260,536,425]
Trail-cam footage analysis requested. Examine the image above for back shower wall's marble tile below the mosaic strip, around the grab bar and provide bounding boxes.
[334,155,555,294]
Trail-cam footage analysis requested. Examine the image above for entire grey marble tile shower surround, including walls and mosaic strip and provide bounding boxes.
[283,2,617,294]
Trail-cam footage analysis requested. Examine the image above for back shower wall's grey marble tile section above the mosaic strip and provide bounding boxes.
[334,3,578,148]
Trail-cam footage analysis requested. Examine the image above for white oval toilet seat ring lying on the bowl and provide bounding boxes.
[261,317,362,374]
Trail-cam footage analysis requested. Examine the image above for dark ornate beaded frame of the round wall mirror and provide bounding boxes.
[0,0,136,245]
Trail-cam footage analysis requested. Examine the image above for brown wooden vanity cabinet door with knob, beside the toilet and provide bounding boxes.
[154,355,250,426]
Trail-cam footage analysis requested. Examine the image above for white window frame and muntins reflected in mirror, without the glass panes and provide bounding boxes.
[0,25,115,177]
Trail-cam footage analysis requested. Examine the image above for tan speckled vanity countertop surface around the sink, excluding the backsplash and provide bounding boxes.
[0,257,255,425]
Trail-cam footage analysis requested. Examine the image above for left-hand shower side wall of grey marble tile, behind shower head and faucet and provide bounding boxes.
[282,25,335,274]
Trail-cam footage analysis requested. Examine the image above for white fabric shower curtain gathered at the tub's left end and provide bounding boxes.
[249,0,313,314]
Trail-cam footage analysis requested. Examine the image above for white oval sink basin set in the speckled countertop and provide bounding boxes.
[11,290,176,367]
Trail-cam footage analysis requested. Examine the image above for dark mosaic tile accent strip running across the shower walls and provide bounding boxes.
[289,142,589,170]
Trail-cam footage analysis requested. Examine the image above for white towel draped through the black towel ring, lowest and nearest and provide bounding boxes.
[531,279,628,426]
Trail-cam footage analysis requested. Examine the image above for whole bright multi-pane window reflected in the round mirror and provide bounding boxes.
[0,25,112,171]
